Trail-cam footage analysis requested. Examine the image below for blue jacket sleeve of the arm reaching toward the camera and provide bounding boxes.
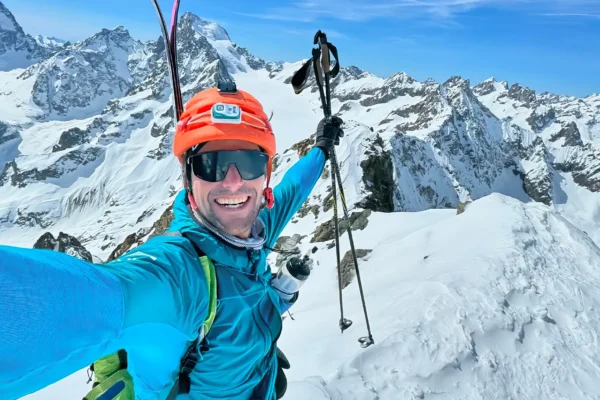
[0,237,208,399]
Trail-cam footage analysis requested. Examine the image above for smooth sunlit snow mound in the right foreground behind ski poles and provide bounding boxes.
[279,194,600,400]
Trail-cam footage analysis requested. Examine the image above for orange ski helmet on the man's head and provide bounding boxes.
[173,88,275,170]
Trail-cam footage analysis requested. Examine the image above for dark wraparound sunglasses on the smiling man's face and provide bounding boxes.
[188,150,269,182]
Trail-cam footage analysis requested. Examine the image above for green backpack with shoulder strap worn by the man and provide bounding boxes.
[83,232,217,400]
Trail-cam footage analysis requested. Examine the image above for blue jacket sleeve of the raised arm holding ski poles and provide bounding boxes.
[261,147,325,247]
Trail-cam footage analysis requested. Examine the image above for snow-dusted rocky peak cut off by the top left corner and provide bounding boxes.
[0,2,49,71]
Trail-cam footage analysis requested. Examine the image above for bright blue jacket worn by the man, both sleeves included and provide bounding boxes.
[0,148,325,400]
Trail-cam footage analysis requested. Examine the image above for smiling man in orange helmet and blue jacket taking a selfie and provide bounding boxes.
[0,83,343,400]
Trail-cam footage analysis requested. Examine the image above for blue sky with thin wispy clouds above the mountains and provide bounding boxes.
[0,0,600,96]
